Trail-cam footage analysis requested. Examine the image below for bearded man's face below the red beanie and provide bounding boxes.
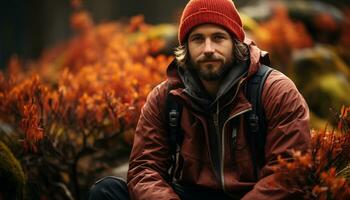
[188,24,233,81]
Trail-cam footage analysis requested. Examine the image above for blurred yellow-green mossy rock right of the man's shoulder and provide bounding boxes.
[291,45,350,123]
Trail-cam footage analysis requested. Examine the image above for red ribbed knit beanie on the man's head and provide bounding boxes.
[178,0,245,44]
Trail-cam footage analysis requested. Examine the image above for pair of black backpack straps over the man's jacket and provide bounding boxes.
[166,65,273,180]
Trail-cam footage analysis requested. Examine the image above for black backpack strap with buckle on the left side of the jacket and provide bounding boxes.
[166,84,183,179]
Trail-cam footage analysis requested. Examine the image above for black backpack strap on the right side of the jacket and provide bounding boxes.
[245,64,273,180]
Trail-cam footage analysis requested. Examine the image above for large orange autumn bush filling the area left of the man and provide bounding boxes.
[0,6,172,199]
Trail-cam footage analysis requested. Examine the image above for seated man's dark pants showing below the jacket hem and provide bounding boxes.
[89,176,232,200]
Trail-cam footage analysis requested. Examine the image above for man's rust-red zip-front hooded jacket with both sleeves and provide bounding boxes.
[127,41,310,200]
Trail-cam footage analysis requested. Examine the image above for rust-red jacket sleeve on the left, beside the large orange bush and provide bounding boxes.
[127,83,179,200]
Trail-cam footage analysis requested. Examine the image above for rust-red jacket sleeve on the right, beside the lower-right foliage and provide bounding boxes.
[242,71,311,200]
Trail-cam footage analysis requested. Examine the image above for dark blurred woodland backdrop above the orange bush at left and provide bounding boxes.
[0,0,191,68]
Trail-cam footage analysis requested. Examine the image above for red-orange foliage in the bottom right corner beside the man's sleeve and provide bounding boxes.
[276,107,350,200]
